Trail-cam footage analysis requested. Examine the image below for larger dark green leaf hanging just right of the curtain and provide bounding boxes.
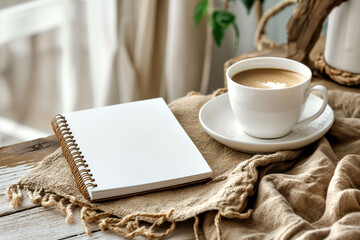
[210,10,238,47]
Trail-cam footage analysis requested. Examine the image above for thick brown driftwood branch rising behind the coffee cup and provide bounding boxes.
[286,0,346,68]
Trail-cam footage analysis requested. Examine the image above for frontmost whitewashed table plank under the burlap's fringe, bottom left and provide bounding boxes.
[0,202,198,240]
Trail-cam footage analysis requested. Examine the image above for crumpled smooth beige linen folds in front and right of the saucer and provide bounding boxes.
[203,90,360,240]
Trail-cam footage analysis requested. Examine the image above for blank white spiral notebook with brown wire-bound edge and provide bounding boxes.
[51,98,212,202]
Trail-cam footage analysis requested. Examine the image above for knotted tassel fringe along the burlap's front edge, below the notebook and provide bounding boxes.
[7,184,176,239]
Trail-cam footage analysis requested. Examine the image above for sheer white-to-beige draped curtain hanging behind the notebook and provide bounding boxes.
[87,0,211,106]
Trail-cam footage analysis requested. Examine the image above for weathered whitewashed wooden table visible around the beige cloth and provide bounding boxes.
[0,38,360,239]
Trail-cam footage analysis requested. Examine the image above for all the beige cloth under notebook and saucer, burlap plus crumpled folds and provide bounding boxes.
[8,91,360,239]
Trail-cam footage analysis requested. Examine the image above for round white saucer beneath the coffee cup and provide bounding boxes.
[199,93,334,153]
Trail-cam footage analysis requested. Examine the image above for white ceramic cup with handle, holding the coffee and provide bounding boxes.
[226,57,328,138]
